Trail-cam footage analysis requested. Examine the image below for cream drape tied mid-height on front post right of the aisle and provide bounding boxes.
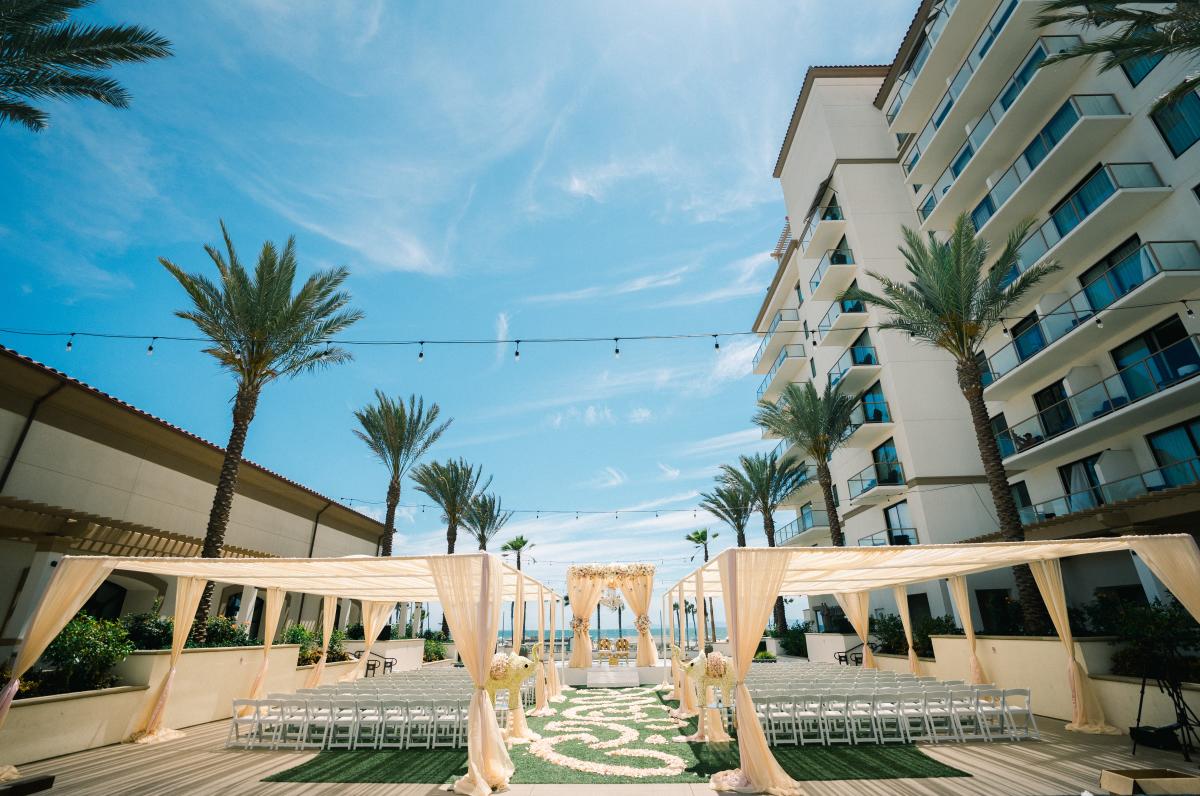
[709,549,804,796]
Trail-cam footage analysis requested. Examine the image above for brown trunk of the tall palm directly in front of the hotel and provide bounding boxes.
[956,359,1050,634]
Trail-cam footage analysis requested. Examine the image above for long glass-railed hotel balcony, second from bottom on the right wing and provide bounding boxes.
[996,335,1200,469]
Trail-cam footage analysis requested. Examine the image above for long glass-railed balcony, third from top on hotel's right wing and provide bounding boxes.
[919,45,1099,228]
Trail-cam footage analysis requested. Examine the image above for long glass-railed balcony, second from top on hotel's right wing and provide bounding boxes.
[904,0,1040,185]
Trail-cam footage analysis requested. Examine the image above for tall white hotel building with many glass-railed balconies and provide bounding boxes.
[755,0,1200,630]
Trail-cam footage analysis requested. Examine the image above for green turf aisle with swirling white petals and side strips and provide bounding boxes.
[266,688,970,784]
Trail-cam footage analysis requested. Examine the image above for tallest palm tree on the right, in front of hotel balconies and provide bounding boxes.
[842,213,1058,632]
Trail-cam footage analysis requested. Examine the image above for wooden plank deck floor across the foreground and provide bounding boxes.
[20,719,1196,796]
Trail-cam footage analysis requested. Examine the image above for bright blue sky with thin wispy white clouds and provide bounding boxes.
[0,0,914,622]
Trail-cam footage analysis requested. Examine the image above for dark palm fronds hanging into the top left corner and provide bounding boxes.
[0,0,170,132]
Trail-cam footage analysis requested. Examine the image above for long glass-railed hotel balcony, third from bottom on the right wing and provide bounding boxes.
[984,240,1200,401]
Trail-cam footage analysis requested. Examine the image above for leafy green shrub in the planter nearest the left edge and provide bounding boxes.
[29,614,134,696]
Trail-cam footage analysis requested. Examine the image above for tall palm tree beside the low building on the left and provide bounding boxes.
[158,222,362,641]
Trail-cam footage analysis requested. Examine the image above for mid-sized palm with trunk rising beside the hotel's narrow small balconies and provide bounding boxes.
[754,382,859,547]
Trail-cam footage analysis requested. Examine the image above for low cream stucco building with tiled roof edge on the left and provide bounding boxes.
[0,347,384,660]
